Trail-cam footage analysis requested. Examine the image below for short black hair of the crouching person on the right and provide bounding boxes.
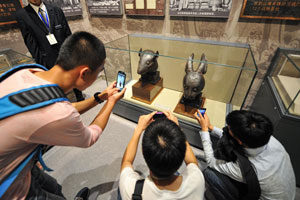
[226,110,273,148]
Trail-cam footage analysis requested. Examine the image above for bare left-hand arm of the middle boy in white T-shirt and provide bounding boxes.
[121,111,156,171]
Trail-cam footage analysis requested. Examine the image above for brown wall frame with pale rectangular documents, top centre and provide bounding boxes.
[124,0,165,16]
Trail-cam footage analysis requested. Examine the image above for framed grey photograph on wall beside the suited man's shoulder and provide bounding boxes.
[43,0,82,16]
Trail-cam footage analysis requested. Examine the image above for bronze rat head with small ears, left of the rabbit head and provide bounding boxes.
[137,48,160,84]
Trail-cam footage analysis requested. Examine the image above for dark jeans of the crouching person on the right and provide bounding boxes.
[203,167,247,200]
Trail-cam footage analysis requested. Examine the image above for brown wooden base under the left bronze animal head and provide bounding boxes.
[131,78,163,104]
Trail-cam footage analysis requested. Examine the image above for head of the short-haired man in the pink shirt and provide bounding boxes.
[56,31,106,90]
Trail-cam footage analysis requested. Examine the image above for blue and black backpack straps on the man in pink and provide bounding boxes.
[0,64,69,199]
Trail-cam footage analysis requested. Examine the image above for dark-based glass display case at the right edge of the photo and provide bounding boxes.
[250,48,300,186]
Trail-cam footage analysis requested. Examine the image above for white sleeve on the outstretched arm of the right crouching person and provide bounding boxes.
[200,131,244,182]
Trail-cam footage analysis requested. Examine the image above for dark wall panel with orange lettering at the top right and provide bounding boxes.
[240,0,300,20]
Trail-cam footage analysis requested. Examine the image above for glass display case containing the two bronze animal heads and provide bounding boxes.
[105,34,257,146]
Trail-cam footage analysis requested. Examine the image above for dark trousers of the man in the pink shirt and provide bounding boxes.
[26,165,66,200]
